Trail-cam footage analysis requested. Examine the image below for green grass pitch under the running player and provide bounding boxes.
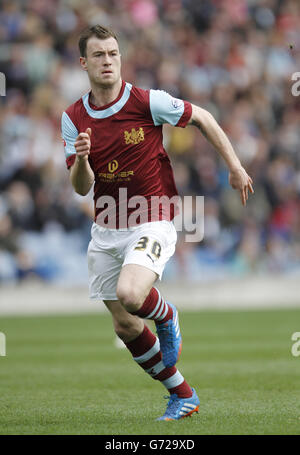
[0,310,300,435]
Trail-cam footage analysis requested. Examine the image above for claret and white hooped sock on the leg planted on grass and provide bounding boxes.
[125,325,193,398]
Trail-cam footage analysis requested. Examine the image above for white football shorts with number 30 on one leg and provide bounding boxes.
[87,220,177,300]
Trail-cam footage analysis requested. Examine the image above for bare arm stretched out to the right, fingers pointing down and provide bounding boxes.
[188,104,254,205]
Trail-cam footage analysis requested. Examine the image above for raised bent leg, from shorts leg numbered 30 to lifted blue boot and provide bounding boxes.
[117,222,182,367]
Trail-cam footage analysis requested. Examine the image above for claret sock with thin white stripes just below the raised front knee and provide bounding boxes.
[131,288,173,324]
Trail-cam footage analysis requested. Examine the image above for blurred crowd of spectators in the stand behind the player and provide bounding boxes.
[0,0,300,285]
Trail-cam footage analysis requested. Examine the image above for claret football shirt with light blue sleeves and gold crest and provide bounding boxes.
[62,81,192,227]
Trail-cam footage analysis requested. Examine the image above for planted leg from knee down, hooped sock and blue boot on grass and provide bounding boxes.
[104,301,199,420]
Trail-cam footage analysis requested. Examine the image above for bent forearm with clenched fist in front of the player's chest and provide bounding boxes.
[70,128,95,196]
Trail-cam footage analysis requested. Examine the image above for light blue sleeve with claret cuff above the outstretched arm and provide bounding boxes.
[149,90,192,128]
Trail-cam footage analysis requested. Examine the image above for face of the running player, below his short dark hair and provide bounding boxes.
[80,36,121,88]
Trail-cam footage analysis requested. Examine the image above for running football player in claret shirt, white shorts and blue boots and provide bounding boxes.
[62,25,253,420]
